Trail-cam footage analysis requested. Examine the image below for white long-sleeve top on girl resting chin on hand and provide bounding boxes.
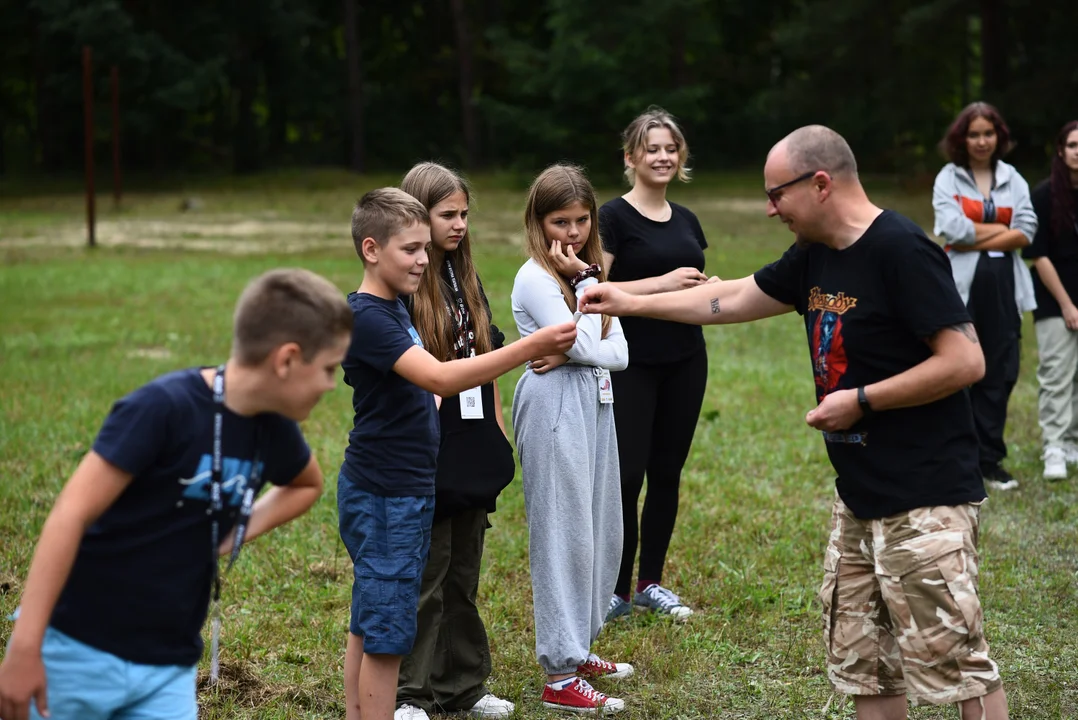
[512,260,628,371]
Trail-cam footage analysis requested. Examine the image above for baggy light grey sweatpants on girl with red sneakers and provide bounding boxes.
[513,365,622,675]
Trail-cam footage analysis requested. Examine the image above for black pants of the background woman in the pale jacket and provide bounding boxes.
[966,252,1022,471]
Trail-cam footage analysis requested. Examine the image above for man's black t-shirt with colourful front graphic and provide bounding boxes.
[756,210,985,520]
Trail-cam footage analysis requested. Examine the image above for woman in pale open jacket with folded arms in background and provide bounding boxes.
[932,102,1037,489]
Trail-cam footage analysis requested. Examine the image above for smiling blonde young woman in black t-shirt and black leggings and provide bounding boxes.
[599,107,707,620]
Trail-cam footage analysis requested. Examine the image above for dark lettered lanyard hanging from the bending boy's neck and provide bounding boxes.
[209,365,262,682]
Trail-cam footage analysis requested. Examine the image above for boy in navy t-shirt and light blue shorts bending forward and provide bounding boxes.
[0,269,351,720]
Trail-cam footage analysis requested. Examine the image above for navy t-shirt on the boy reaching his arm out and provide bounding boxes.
[341,292,439,497]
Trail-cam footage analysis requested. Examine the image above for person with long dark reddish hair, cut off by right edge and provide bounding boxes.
[1023,121,1078,480]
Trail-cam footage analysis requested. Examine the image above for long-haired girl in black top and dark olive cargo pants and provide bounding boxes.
[395,163,515,720]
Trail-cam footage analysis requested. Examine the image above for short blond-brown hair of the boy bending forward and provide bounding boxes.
[232,267,353,365]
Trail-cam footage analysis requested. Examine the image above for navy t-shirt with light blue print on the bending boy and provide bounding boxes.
[51,368,310,665]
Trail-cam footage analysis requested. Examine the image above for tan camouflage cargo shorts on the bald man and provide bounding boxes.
[820,497,1003,705]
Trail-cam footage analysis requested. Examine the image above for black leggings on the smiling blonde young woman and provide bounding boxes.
[612,347,707,595]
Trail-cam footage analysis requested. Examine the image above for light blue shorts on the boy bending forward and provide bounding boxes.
[30,627,198,720]
